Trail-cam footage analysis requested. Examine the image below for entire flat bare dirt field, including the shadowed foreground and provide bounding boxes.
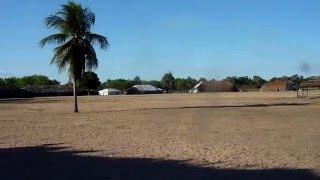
[0,92,320,179]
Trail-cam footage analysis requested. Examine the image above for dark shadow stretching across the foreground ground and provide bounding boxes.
[0,145,319,180]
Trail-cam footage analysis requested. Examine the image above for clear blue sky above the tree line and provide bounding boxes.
[0,0,320,82]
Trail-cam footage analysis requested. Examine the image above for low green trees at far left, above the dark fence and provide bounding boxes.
[0,75,60,88]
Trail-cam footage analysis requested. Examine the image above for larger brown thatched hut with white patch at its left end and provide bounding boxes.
[190,81,236,93]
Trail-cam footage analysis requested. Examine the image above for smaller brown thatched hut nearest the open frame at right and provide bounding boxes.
[261,80,294,91]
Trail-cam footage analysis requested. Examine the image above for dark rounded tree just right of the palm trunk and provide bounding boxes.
[80,71,101,95]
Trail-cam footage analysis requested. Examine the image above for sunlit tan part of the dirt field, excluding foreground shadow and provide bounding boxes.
[0,92,320,179]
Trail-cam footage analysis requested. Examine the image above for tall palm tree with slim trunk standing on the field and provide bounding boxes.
[40,1,109,112]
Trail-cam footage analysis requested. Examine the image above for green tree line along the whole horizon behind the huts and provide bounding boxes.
[0,71,319,92]
